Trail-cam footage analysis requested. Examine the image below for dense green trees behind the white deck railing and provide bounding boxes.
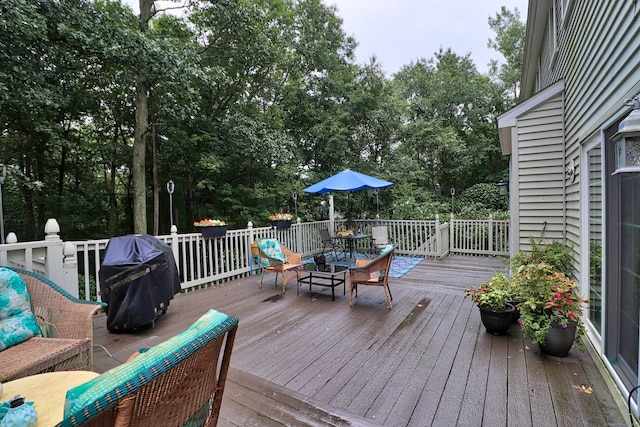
[0,0,524,237]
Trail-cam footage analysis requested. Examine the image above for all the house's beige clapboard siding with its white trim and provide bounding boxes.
[499,0,640,412]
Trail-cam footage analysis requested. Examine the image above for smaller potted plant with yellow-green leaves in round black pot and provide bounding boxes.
[465,272,515,335]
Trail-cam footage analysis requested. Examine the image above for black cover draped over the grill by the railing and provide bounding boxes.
[99,234,180,331]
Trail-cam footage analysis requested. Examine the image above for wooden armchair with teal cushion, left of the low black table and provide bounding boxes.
[258,239,302,294]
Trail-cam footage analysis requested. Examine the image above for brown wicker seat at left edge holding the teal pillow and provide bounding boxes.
[0,267,104,382]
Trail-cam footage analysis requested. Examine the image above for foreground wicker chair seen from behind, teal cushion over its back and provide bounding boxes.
[58,310,238,427]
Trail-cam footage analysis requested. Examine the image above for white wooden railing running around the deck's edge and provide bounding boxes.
[0,217,509,300]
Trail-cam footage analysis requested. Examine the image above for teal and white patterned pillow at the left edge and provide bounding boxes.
[0,267,40,350]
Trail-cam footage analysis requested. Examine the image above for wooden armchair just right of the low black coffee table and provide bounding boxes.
[349,245,395,310]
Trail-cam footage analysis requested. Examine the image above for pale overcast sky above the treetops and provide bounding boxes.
[123,0,528,76]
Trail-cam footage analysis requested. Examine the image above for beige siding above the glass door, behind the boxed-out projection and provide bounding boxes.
[525,0,640,290]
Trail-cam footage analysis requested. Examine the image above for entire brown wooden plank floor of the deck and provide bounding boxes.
[94,256,629,427]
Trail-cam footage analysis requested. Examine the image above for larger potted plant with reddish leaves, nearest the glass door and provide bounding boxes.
[513,262,588,357]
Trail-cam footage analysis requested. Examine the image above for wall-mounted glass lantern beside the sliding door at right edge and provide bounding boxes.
[611,96,640,175]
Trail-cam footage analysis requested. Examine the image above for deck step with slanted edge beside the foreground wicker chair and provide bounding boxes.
[218,368,379,427]
